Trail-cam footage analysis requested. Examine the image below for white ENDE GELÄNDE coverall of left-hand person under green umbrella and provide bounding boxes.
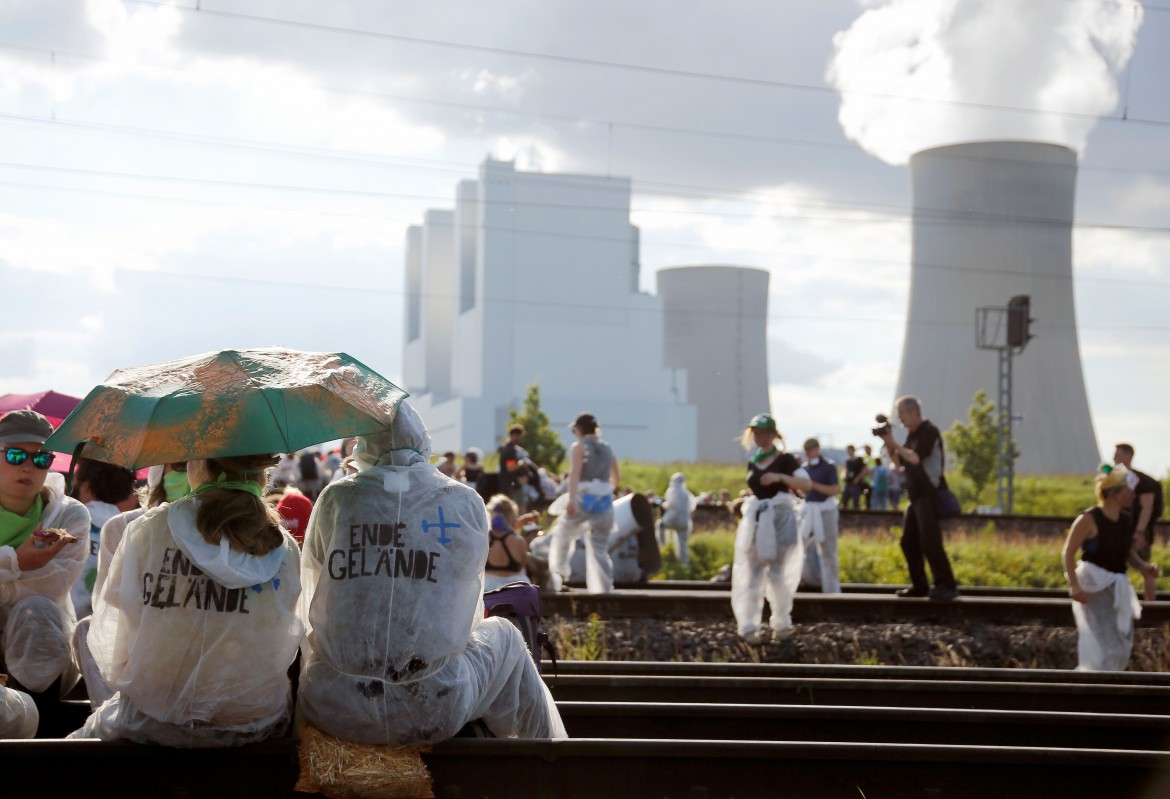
[70,496,303,748]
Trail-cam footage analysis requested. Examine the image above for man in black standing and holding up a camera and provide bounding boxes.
[873,397,958,601]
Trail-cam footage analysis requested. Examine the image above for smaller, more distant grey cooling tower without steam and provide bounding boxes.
[658,267,769,463]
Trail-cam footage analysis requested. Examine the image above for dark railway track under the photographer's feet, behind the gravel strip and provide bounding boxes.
[542,587,1170,627]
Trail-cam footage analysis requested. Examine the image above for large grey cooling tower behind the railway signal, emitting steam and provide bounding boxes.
[897,142,1099,474]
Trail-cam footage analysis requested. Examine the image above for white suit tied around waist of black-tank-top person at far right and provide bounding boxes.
[1073,560,1142,671]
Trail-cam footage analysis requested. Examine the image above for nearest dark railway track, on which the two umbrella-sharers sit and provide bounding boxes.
[9,661,1170,799]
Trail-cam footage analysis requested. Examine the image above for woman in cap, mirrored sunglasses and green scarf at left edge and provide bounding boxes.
[0,411,89,737]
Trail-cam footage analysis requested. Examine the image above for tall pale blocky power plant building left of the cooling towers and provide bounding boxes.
[404,159,697,461]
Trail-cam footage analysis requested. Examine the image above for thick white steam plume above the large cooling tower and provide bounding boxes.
[827,0,1143,164]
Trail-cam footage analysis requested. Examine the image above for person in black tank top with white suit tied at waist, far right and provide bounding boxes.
[1061,463,1158,671]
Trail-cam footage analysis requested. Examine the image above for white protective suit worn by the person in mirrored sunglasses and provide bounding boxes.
[0,473,89,693]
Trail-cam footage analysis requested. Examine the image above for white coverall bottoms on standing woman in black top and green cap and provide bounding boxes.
[731,494,804,641]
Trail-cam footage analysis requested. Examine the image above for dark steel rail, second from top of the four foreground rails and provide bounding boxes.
[544,674,1170,716]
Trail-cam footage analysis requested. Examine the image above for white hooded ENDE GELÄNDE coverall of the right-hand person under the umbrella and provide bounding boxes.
[297,402,566,745]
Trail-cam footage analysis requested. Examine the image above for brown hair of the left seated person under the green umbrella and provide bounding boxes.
[195,455,284,555]
